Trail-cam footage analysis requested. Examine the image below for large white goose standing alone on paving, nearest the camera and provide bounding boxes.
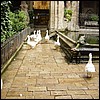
[85,53,95,78]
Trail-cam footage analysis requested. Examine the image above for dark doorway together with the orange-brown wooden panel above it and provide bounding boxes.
[29,1,50,28]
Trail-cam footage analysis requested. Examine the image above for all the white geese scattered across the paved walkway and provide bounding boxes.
[1,30,95,89]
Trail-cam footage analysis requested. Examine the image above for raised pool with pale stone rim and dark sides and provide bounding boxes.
[55,30,99,63]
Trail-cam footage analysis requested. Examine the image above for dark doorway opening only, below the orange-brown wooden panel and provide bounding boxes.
[28,9,50,28]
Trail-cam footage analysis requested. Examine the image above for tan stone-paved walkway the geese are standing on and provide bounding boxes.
[1,41,99,99]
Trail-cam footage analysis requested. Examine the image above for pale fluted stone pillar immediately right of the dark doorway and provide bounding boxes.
[50,1,64,31]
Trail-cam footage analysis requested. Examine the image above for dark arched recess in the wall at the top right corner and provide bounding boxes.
[79,1,99,28]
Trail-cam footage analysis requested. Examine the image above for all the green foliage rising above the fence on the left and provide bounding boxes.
[1,1,27,42]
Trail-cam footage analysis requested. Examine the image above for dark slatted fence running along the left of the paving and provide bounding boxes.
[1,27,30,69]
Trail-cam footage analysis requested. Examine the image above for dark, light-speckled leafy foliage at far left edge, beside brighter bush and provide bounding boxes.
[1,1,13,42]
